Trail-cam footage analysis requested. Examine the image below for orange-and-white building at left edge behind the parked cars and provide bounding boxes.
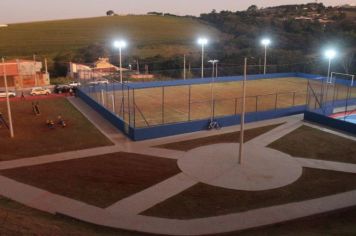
[0,60,50,89]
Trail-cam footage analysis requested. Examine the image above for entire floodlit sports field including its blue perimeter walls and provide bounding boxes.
[80,73,356,140]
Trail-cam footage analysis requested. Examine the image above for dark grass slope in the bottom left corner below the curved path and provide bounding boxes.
[0,196,147,236]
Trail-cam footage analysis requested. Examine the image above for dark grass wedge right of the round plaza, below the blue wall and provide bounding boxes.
[268,126,356,164]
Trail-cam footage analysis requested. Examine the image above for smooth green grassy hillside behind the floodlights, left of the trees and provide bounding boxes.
[0,15,219,57]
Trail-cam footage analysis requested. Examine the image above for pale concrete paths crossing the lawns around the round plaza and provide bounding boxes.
[0,98,356,235]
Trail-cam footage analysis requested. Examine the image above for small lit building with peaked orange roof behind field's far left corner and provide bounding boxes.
[68,58,128,80]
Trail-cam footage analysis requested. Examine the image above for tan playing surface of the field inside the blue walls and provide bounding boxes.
[89,77,308,128]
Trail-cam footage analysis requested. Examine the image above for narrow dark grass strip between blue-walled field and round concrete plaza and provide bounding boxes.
[156,124,281,151]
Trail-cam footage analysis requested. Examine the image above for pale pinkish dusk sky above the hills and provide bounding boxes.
[0,0,356,24]
